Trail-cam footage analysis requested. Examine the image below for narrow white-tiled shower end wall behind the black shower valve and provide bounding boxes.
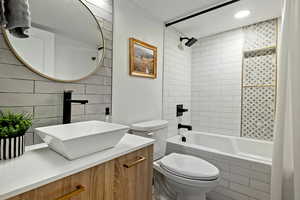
[163,28,191,137]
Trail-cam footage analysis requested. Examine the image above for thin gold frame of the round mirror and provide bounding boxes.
[1,0,105,83]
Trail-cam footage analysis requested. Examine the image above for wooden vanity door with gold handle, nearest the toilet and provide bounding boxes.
[114,146,153,200]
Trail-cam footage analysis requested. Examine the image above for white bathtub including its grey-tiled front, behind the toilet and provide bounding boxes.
[167,131,273,200]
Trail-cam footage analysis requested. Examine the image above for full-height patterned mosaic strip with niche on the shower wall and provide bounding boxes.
[241,19,278,141]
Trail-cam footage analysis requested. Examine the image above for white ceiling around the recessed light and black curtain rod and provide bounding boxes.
[132,0,282,38]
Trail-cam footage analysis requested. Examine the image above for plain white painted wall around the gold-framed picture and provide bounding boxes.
[112,0,163,124]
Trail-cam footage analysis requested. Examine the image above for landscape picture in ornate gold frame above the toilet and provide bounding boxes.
[129,38,157,79]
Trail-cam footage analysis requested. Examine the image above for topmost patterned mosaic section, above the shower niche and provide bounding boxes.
[244,19,277,51]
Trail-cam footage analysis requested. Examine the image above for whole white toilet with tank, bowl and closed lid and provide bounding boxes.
[131,120,219,200]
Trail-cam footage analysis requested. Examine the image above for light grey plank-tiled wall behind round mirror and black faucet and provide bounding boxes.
[0,0,113,145]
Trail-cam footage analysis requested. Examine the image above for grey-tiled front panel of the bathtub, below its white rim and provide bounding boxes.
[167,143,271,200]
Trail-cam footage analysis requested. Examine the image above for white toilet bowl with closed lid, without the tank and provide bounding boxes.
[153,153,220,200]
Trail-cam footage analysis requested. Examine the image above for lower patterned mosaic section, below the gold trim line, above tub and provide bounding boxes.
[242,87,275,141]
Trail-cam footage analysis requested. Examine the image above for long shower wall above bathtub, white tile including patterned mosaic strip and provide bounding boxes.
[191,19,278,140]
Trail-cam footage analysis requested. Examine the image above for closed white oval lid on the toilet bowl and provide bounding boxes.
[160,153,219,181]
